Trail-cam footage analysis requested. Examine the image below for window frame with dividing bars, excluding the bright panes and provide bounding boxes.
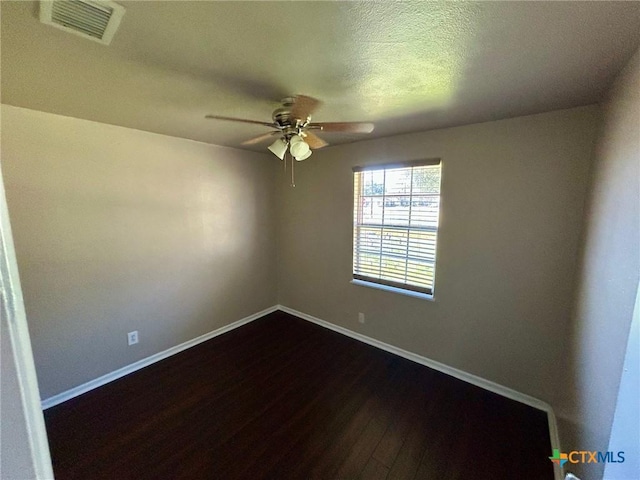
[351,158,442,300]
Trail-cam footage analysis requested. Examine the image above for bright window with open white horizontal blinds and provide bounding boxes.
[353,160,441,295]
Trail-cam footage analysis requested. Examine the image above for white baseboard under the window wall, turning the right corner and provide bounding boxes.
[278,305,563,480]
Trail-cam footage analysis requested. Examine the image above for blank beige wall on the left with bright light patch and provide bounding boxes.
[2,105,276,398]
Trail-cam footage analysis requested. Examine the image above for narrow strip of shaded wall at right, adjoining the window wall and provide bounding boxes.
[556,51,640,479]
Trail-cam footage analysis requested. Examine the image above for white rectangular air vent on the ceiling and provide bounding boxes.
[40,0,124,45]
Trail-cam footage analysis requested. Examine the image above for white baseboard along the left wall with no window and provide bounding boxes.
[41,305,278,410]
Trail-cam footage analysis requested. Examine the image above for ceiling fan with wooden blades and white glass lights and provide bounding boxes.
[205,95,373,161]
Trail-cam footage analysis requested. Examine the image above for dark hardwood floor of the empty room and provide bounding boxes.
[45,312,553,480]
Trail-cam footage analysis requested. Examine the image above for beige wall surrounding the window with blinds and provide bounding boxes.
[278,106,599,401]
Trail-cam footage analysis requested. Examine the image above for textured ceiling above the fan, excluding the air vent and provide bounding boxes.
[0,1,640,150]
